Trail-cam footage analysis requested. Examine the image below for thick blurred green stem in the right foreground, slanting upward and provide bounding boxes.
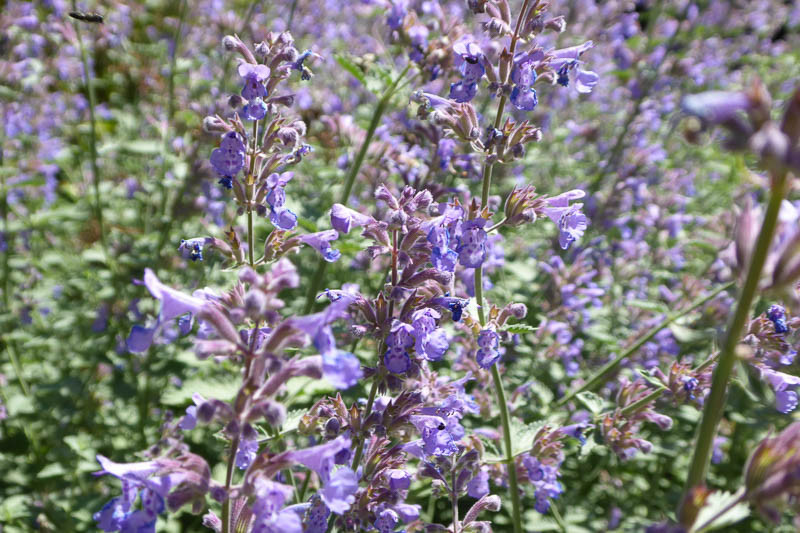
[682,171,788,501]
